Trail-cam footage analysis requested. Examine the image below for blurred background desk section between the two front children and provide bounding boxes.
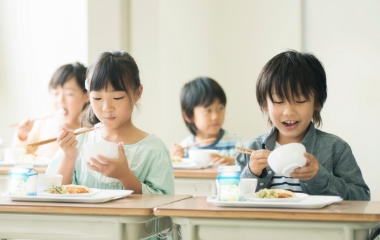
[174,167,218,196]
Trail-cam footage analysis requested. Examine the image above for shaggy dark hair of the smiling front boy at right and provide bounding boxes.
[256,50,327,127]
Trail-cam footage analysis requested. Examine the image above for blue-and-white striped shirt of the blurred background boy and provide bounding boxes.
[180,129,242,158]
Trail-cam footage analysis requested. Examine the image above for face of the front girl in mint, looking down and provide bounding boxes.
[90,86,142,129]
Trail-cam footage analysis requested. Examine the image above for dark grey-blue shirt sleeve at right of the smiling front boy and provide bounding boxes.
[300,143,371,201]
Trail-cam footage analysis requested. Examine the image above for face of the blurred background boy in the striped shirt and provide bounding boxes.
[192,99,225,138]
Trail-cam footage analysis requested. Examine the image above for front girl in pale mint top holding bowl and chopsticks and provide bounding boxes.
[47,51,174,194]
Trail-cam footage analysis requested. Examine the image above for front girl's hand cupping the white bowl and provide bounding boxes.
[87,143,130,180]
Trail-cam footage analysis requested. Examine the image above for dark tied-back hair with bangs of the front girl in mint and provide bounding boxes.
[82,50,141,126]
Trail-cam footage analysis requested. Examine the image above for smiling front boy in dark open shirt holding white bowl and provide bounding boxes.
[236,51,370,200]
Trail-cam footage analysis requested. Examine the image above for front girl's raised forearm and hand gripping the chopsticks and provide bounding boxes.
[57,130,78,185]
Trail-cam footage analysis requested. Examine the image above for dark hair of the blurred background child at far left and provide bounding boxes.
[49,62,87,93]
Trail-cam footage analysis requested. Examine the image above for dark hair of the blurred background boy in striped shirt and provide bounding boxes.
[180,77,227,135]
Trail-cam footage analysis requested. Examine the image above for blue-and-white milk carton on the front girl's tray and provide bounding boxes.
[9,166,38,196]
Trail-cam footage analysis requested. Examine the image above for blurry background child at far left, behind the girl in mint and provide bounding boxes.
[12,63,89,158]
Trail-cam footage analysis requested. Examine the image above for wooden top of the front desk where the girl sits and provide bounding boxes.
[0,194,191,216]
